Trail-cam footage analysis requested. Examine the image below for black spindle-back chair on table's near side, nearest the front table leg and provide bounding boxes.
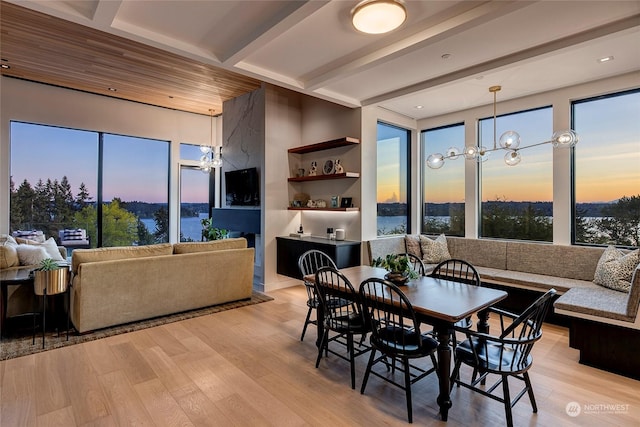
[359,278,438,423]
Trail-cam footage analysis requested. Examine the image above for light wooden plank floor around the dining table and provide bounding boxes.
[0,286,640,427]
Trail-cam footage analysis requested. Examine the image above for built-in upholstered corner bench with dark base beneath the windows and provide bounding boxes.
[366,236,640,379]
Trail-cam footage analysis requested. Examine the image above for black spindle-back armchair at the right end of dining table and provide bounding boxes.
[451,289,556,427]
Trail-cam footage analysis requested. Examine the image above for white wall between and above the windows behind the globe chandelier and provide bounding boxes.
[418,72,640,245]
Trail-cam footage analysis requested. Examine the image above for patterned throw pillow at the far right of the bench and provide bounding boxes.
[593,246,640,292]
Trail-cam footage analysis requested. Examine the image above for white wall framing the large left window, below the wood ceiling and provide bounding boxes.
[0,77,220,242]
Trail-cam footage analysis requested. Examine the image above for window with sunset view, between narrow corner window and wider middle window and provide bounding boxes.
[421,123,465,236]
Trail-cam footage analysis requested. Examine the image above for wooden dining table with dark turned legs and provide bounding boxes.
[313,265,507,421]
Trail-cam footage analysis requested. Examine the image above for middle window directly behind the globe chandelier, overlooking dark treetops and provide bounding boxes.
[478,107,553,242]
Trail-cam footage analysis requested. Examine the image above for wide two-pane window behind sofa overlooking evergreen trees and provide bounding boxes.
[10,122,169,247]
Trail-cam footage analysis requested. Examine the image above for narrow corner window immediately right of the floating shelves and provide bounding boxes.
[377,122,411,236]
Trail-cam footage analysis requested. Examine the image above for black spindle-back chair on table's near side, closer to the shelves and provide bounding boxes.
[315,267,371,389]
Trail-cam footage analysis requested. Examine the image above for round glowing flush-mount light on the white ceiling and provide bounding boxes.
[351,0,407,34]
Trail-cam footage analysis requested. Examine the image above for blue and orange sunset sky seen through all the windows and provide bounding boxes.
[11,92,640,209]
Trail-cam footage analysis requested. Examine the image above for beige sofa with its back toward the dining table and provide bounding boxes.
[71,238,254,333]
